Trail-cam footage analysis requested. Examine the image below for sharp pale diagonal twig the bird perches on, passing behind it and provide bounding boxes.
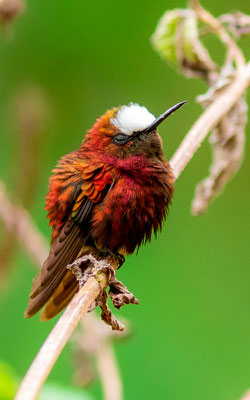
[15,63,250,400]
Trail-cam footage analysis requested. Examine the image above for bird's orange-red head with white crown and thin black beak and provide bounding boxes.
[83,101,185,159]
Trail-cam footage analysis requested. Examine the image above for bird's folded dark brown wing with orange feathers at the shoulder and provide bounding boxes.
[24,162,113,319]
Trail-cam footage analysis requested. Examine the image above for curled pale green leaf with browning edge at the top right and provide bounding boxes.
[152,9,216,80]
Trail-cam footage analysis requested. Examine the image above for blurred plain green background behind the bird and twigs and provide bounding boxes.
[0,0,250,400]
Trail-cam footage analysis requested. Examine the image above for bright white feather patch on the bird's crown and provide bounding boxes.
[111,103,155,135]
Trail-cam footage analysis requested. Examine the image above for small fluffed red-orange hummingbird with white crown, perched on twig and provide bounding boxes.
[25,102,185,320]
